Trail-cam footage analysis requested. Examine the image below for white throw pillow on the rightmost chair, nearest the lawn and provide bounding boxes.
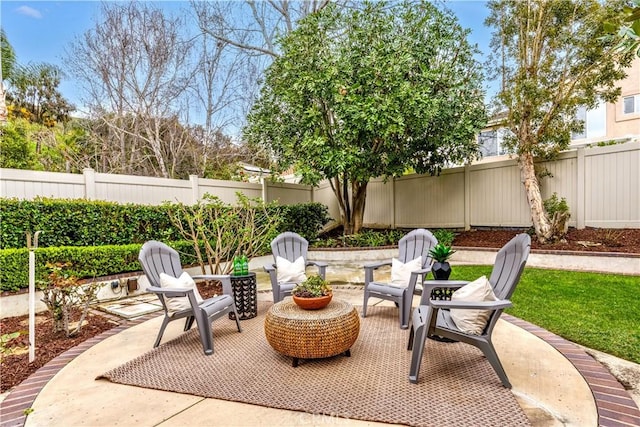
[449,276,498,335]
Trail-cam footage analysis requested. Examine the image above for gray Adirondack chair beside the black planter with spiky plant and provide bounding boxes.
[362,228,438,329]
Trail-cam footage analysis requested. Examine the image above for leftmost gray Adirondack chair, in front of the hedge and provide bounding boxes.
[138,240,242,355]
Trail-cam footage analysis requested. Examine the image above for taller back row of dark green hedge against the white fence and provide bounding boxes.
[0,198,330,249]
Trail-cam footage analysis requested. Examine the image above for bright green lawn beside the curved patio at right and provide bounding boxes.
[451,266,640,363]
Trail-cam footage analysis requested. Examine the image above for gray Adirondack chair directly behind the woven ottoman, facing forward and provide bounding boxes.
[264,231,327,303]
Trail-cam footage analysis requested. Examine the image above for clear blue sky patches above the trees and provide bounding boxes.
[0,0,490,116]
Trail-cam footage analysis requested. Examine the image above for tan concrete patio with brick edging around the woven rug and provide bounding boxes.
[0,249,640,426]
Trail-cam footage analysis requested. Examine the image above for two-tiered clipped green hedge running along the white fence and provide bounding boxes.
[0,198,330,292]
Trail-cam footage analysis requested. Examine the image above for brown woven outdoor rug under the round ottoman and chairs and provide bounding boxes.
[98,304,530,426]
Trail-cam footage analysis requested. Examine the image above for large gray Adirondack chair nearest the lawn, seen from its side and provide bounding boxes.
[408,233,531,388]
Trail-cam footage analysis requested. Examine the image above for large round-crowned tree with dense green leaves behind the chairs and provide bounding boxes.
[244,1,485,233]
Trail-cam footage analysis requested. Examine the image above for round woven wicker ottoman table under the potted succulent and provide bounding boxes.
[264,298,360,367]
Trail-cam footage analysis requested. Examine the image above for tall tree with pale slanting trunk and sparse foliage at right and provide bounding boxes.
[486,0,631,242]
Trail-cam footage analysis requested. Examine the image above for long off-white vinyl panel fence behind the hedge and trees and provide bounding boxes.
[0,142,640,228]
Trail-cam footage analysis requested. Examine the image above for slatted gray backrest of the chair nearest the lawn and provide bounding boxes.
[489,233,531,299]
